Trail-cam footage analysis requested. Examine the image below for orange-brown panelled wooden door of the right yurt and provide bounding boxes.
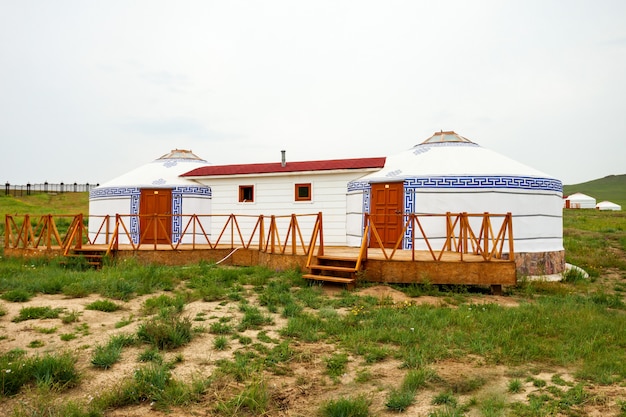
[370,182,404,248]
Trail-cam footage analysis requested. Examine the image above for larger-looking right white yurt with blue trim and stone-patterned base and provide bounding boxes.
[348,131,565,275]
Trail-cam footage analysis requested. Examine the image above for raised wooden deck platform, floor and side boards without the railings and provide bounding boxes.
[5,245,517,292]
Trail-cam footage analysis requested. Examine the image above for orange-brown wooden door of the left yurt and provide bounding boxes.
[139,189,172,244]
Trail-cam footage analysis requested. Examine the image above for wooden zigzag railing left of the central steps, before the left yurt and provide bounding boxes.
[4,213,323,255]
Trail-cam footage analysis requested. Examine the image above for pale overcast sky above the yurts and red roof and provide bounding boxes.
[0,0,626,184]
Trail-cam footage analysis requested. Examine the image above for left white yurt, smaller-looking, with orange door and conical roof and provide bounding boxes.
[89,149,211,244]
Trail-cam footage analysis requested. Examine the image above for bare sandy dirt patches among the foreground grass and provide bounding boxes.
[0,286,626,417]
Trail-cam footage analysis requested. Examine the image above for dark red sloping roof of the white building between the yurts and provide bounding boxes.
[181,157,386,177]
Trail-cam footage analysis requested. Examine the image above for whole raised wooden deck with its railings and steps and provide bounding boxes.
[4,213,517,288]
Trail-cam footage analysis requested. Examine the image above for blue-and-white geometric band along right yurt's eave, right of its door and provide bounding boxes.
[404,175,563,192]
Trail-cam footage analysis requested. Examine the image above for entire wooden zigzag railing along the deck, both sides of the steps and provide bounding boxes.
[4,212,514,268]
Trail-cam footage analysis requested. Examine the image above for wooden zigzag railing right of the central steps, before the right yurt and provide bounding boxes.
[359,213,514,261]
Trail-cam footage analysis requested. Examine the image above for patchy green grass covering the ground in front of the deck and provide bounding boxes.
[0,200,626,416]
